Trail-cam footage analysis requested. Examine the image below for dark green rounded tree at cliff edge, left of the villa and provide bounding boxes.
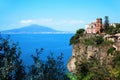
[70,29,85,45]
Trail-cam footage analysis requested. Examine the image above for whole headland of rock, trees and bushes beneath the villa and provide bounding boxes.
[67,27,120,80]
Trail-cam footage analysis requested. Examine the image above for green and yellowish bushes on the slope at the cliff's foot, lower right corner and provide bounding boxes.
[73,48,120,80]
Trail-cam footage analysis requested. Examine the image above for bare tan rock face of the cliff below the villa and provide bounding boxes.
[67,34,113,73]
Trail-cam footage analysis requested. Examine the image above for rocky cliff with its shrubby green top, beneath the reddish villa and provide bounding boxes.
[67,34,120,73]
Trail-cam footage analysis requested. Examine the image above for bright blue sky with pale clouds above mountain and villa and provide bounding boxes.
[0,0,120,31]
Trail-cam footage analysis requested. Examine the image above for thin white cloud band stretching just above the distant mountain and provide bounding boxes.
[20,18,84,25]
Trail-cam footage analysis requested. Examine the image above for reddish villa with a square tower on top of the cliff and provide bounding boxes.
[86,18,102,33]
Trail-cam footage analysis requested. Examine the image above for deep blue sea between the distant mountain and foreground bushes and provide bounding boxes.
[2,34,73,65]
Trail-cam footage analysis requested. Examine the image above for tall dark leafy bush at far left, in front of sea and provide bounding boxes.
[0,36,26,80]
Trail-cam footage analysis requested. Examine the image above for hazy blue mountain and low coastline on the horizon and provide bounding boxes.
[0,24,74,34]
